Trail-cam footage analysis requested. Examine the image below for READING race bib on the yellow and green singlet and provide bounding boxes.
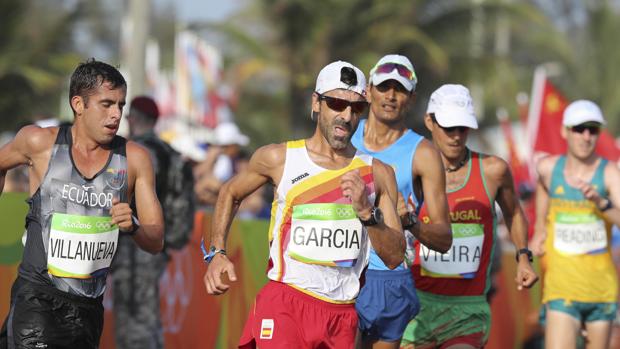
[553,212,607,255]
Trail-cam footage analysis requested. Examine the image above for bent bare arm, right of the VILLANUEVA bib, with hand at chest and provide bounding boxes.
[115,141,164,254]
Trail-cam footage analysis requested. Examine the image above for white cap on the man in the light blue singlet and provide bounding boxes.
[369,55,418,92]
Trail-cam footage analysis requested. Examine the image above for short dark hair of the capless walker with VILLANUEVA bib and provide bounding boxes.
[69,58,127,114]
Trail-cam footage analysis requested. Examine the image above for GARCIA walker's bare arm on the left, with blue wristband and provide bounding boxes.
[204,143,286,295]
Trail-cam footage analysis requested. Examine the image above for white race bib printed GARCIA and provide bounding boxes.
[288,204,363,267]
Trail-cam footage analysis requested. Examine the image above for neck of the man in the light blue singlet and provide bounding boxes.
[363,111,408,151]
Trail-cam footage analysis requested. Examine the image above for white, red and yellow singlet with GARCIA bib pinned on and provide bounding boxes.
[267,140,375,303]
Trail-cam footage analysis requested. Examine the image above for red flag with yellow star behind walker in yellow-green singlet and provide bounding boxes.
[527,68,620,162]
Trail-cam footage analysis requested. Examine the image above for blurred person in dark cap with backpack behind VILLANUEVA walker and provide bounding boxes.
[113,96,194,349]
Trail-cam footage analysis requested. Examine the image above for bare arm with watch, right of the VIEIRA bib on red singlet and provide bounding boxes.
[482,156,538,290]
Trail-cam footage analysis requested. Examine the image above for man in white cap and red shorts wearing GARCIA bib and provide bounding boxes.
[204,61,405,348]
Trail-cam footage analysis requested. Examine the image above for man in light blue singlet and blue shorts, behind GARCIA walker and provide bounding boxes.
[352,54,452,348]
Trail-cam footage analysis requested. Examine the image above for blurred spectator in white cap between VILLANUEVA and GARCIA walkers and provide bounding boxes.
[194,122,250,207]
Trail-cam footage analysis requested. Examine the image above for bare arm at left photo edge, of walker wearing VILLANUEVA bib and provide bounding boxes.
[0,125,58,195]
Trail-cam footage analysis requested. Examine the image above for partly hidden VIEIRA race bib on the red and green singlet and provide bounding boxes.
[420,223,484,279]
